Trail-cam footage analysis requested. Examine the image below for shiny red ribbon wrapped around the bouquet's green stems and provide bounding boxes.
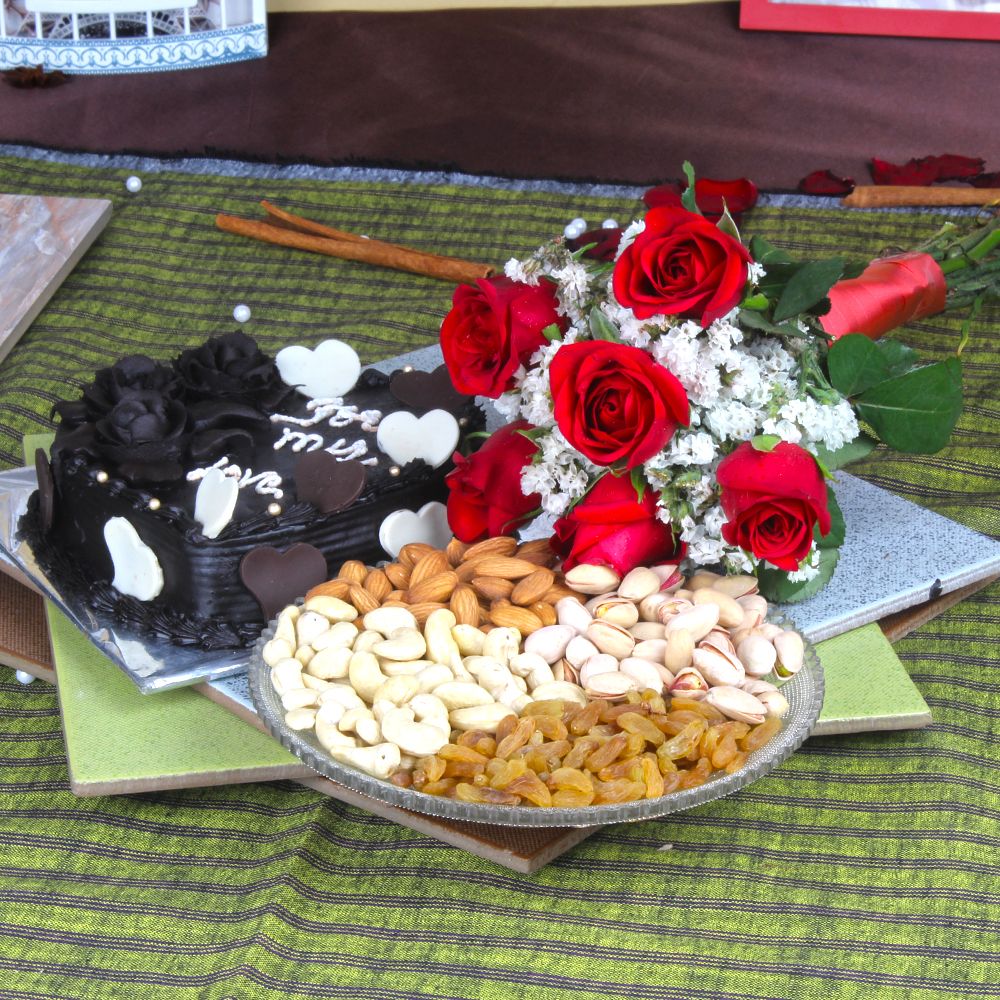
[820,253,948,340]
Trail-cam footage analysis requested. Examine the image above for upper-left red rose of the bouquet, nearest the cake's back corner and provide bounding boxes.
[441,276,566,399]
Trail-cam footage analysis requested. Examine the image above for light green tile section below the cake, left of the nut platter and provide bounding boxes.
[46,605,305,795]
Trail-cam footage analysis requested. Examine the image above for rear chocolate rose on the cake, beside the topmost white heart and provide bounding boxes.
[174,330,292,409]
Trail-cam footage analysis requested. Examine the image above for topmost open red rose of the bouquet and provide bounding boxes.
[613,206,750,326]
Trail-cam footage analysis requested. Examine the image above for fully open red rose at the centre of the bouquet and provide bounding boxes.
[549,340,690,469]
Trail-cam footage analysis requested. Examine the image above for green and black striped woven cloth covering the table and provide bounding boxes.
[0,150,1000,1000]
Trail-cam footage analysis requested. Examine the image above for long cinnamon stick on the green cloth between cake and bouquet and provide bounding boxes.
[215,213,493,282]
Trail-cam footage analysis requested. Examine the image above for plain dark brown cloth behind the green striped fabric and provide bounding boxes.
[0,3,1000,189]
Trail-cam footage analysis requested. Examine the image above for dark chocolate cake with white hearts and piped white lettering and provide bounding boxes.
[26,333,483,648]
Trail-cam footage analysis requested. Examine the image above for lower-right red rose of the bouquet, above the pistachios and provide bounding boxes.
[716,441,830,570]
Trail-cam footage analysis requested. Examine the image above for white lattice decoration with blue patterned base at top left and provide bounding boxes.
[0,0,267,73]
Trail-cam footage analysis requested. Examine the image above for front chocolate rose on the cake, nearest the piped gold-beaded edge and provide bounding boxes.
[94,392,189,482]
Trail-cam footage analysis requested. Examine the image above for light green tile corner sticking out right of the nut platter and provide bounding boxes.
[813,624,931,735]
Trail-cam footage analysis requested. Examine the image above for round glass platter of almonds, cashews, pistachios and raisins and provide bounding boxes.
[250,537,823,826]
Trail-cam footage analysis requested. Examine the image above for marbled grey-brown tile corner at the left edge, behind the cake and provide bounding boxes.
[0,194,111,361]
